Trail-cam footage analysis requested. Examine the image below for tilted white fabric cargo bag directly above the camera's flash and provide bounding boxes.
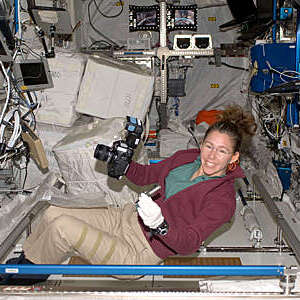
[76,56,154,120]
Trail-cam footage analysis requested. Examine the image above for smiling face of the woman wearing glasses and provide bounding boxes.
[200,130,239,176]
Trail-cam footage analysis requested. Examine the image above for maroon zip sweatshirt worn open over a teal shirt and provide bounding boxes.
[126,149,245,259]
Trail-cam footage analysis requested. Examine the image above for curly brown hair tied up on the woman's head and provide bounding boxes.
[203,104,257,152]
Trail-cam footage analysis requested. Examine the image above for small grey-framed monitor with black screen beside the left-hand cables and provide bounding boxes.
[12,58,53,91]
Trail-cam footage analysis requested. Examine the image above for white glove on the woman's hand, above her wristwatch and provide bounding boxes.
[137,193,164,229]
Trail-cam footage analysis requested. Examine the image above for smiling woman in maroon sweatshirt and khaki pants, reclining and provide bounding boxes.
[2,106,256,282]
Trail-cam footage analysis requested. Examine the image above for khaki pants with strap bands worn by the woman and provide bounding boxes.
[23,204,161,265]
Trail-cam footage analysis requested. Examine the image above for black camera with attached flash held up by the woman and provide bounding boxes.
[94,117,143,179]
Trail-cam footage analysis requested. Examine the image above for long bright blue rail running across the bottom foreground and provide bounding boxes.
[0,264,285,276]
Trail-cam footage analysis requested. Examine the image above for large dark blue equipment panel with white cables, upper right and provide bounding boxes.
[250,43,296,93]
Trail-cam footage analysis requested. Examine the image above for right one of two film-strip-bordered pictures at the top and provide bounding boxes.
[167,5,197,31]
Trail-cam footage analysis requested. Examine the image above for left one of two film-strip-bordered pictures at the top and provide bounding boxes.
[129,5,160,32]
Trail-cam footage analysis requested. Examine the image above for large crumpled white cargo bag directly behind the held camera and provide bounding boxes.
[53,118,146,206]
